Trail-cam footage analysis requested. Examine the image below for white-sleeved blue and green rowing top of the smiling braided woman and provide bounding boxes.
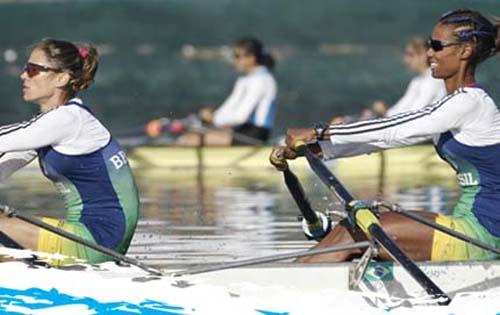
[320,87,500,237]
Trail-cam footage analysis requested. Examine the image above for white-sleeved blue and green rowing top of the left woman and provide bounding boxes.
[0,98,139,250]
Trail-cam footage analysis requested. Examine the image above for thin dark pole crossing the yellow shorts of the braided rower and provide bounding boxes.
[378,203,500,255]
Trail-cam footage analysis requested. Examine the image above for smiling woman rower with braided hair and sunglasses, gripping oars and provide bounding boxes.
[271,10,500,262]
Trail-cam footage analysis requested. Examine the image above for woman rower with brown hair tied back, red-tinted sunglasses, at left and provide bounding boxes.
[0,39,139,264]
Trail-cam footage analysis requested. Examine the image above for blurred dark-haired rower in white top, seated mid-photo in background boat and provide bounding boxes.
[146,38,277,146]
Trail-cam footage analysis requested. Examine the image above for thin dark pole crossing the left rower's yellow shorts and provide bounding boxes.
[0,205,163,276]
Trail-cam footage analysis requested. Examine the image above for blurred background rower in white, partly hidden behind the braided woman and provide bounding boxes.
[332,36,446,124]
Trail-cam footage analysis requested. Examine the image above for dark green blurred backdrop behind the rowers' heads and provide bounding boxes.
[0,0,500,133]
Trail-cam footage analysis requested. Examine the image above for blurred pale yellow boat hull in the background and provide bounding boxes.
[127,145,453,176]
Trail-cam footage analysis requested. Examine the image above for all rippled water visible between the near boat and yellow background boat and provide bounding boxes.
[0,168,458,268]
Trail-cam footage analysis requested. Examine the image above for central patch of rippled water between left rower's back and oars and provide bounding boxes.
[131,170,309,265]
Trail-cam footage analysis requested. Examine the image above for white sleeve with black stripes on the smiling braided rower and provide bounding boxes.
[320,88,500,158]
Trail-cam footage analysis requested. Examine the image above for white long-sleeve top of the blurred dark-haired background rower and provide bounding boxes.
[213,66,277,129]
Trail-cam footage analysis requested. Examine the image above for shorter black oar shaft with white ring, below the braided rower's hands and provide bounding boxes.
[283,162,331,241]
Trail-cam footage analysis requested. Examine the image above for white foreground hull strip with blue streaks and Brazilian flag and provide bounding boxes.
[0,254,500,315]
